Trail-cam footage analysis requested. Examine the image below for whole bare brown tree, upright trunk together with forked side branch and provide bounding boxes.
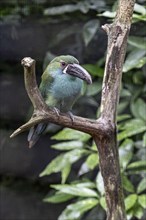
[11,0,135,220]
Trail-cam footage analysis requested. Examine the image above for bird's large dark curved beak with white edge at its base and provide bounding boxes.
[63,63,92,84]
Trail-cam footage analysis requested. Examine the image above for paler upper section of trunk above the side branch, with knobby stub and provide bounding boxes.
[101,0,135,126]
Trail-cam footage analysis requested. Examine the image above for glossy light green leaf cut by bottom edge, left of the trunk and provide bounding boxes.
[58,198,98,220]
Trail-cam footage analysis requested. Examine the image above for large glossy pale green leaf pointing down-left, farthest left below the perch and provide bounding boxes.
[40,149,89,178]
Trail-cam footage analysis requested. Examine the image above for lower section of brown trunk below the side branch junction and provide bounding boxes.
[94,131,126,220]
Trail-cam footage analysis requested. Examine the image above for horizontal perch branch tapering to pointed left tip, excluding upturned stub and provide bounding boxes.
[10,108,109,138]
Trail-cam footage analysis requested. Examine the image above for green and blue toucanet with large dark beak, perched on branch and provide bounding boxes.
[28,55,92,148]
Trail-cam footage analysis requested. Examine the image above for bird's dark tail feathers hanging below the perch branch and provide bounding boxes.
[27,123,47,148]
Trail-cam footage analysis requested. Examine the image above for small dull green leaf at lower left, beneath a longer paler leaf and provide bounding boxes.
[43,192,74,203]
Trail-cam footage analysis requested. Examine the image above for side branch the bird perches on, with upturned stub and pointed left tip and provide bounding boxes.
[10,57,109,138]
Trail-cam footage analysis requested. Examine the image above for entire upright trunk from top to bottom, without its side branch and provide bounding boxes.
[94,0,135,220]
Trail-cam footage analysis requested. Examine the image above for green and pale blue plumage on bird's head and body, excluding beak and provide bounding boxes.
[40,56,83,112]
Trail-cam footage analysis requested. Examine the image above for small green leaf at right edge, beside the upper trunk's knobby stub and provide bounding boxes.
[128,36,146,49]
